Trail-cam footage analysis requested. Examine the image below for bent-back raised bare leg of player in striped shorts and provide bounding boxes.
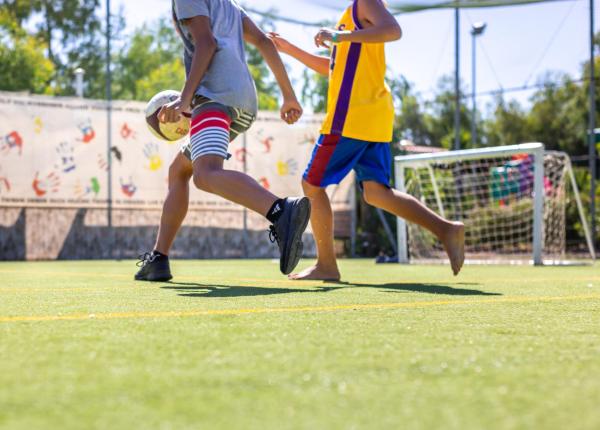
[193,155,277,215]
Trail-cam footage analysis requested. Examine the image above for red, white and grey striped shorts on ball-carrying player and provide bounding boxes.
[181,96,256,162]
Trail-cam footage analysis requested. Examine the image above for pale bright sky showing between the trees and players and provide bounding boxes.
[112,0,600,110]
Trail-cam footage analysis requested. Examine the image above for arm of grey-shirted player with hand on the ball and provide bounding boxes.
[158,16,217,122]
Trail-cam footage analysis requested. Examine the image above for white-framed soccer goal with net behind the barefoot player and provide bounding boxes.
[395,143,595,265]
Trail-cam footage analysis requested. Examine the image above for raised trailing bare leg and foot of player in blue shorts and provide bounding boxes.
[363,181,465,275]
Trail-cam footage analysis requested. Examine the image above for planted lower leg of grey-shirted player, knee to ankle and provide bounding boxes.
[154,153,192,255]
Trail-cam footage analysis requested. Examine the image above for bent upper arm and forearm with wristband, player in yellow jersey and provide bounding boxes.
[315,0,402,48]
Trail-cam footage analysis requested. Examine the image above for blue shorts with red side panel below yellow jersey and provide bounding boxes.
[303,134,392,187]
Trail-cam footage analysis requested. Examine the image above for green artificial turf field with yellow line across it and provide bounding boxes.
[0,260,600,429]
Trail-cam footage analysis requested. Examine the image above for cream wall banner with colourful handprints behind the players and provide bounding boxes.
[0,92,353,260]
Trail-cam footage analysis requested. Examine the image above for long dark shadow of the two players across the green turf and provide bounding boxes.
[161,281,502,297]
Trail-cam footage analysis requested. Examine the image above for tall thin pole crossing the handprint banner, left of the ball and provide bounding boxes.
[106,0,114,258]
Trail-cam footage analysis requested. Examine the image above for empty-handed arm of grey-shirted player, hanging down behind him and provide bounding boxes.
[244,17,302,124]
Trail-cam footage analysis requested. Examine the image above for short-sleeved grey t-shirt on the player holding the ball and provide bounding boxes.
[172,0,258,114]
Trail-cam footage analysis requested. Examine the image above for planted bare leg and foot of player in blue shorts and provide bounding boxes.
[289,181,340,281]
